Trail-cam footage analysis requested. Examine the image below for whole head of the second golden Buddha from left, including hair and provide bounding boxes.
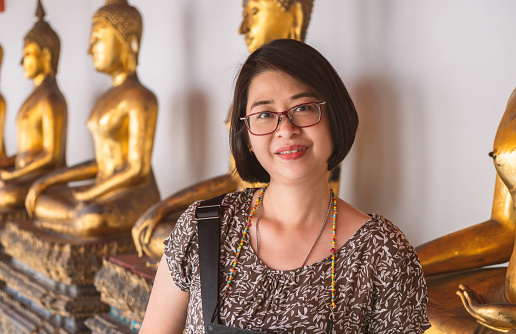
[88,0,142,73]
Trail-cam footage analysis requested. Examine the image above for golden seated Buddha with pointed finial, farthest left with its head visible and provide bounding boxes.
[0,1,68,212]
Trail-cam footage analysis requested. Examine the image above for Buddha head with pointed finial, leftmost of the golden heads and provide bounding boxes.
[22,0,61,78]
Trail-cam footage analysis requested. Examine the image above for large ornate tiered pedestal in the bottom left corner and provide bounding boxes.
[0,220,134,333]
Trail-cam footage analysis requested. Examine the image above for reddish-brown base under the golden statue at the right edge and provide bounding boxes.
[425,267,507,334]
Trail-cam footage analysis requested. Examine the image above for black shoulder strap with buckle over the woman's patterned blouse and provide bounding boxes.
[195,194,226,328]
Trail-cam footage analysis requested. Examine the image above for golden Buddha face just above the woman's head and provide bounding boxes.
[239,0,301,52]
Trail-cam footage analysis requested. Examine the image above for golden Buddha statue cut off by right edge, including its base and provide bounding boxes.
[417,90,516,334]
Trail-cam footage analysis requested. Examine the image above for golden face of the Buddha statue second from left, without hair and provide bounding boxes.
[88,22,123,73]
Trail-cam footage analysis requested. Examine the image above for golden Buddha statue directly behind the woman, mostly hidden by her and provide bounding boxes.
[132,0,340,265]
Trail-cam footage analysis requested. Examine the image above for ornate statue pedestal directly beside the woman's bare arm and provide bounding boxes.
[86,254,156,334]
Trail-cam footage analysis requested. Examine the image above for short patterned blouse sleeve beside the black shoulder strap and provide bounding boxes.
[164,201,200,292]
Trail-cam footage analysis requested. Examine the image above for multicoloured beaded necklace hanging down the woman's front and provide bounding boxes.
[224,184,337,327]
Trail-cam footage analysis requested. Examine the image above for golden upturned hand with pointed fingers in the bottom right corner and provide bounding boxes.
[457,284,516,332]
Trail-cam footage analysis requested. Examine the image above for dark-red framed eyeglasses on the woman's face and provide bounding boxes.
[240,102,326,136]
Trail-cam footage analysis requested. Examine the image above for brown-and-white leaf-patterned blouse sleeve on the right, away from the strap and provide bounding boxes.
[371,248,431,334]
